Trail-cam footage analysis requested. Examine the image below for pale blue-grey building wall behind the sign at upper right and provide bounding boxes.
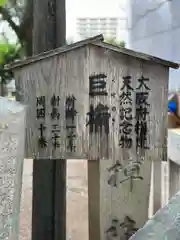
[127,0,180,90]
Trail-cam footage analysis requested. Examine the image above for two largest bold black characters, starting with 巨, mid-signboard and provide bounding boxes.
[86,73,111,134]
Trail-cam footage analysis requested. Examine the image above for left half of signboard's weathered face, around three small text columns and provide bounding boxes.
[14,48,89,159]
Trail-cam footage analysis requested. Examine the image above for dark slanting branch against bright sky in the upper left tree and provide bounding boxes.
[0,6,22,42]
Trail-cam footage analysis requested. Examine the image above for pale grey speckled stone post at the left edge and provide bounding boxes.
[0,97,26,240]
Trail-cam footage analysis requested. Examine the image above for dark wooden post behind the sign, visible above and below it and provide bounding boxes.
[32,0,66,240]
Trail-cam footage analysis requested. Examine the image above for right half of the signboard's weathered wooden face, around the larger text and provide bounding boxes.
[88,44,168,161]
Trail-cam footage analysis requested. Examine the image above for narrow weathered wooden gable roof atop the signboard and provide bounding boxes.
[6,34,179,69]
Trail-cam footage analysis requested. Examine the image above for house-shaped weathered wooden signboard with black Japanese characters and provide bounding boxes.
[9,38,177,164]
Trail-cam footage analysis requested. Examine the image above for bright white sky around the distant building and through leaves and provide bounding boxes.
[0,0,127,42]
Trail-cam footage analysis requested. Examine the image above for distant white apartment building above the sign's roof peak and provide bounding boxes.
[76,17,120,39]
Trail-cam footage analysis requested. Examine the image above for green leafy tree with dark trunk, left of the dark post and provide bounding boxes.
[0,0,33,96]
